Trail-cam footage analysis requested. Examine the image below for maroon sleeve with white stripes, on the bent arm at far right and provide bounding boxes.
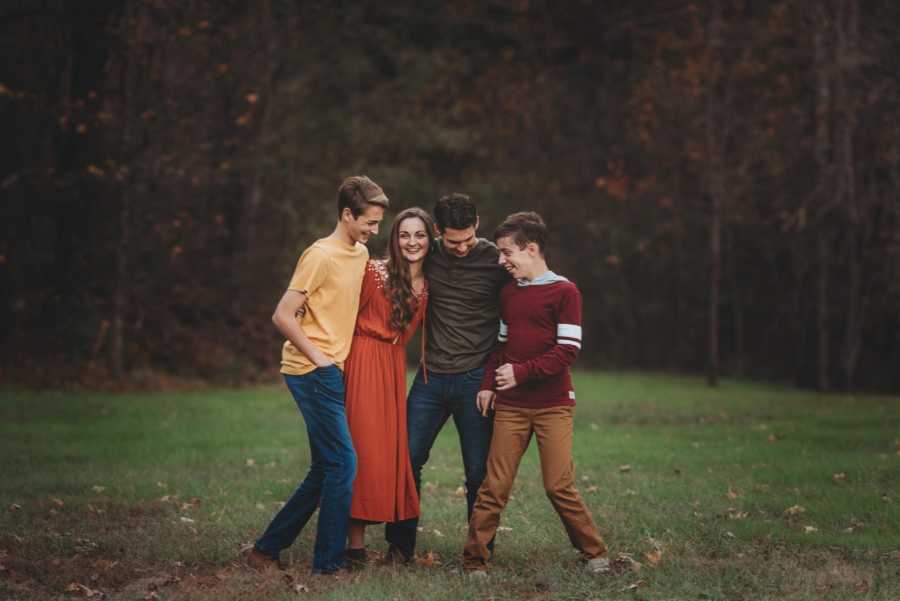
[513,286,581,384]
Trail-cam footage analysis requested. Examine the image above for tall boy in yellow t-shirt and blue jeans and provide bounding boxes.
[247,175,389,574]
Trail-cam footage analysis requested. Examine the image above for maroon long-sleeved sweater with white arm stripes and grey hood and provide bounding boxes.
[481,272,581,408]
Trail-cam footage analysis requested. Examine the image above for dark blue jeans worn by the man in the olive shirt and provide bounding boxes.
[384,367,493,558]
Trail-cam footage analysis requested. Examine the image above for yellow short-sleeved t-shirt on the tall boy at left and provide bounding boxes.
[281,236,369,376]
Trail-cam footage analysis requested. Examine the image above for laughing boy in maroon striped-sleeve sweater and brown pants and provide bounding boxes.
[463,212,609,574]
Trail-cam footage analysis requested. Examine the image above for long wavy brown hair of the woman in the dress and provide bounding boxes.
[385,207,434,332]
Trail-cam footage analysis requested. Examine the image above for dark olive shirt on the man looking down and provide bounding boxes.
[425,238,510,374]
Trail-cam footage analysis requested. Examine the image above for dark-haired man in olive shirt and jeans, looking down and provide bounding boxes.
[385,194,509,561]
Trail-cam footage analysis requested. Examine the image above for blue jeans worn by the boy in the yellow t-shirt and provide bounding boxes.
[256,365,356,573]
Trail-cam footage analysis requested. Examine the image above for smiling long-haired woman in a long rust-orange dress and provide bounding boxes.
[344,208,434,564]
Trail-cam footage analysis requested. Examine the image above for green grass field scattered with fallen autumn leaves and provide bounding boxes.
[0,372,900,601]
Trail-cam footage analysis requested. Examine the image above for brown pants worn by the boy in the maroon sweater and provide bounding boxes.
[463,405,606,569]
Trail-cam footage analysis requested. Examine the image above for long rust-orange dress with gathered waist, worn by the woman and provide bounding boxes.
[344,261,428,522]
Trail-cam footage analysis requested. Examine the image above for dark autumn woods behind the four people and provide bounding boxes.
[0,0,900,391]
